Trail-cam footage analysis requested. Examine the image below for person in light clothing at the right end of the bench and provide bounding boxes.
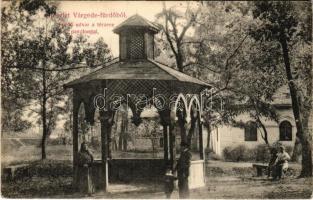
[273,146,290,180]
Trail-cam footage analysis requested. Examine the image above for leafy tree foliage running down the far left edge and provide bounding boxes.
[1,1,35,134]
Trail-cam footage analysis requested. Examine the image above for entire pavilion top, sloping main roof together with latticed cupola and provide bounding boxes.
[65,14,210,88]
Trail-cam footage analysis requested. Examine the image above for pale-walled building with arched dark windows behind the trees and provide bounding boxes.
[209,86,297,156]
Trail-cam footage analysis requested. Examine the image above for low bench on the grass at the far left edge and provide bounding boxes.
[1,164,29,181]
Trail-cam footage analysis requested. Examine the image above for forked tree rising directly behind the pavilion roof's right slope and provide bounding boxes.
[158,4,252,197]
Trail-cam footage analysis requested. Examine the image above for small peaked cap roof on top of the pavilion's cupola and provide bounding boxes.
[113,14,160,34]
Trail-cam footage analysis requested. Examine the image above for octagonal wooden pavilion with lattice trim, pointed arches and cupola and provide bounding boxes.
[65,15,211,191]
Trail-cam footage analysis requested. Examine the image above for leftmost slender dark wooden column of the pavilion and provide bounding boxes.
[72,95,79,187]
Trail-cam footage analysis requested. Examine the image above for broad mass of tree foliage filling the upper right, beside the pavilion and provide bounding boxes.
[155,1,312,176]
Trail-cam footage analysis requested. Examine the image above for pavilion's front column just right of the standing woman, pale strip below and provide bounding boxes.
[100,111,114,191]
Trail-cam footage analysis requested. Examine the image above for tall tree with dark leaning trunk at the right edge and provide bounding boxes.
[250,1,312,177]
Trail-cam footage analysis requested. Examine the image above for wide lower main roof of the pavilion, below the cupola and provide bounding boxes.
[65,59,210,87]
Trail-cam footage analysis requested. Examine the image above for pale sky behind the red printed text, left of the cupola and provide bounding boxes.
[58,1,182,57]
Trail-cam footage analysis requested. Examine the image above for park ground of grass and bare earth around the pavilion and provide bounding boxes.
[2,161,312,199]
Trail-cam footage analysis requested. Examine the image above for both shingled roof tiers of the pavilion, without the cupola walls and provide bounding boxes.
[65,14,210,87]
